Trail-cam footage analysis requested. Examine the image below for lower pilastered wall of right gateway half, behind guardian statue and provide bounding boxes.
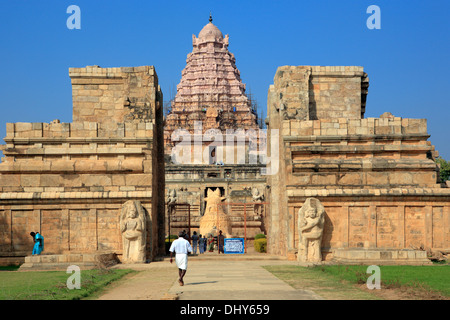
[287,192,450,260]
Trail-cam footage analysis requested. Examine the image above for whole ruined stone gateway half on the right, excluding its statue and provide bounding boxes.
[267,66,450,264]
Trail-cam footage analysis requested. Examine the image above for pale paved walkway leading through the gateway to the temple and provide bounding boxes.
[99,254,321,300]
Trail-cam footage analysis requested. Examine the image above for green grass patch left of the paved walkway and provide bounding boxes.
[0,269,134,300]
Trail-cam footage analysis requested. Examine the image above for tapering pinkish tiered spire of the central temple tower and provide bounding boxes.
[165,17,258,154]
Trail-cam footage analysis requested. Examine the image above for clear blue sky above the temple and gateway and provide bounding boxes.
[0,0,450,160]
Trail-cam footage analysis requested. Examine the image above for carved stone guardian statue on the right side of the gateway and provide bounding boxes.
[297,198,325,262]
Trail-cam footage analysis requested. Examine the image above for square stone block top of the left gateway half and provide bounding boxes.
[69,66,160,122]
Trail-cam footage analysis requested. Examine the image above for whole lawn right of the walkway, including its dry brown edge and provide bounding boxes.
[264,265,450,300]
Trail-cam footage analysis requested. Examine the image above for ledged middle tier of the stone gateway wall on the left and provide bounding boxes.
[0,122,154,195]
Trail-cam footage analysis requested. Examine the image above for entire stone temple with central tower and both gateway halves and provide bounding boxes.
[0,18,450,267]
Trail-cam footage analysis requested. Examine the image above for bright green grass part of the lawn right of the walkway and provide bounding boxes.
[312,265,450,297]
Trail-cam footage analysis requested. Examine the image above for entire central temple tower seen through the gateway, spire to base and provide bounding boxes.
[164,18,267,238]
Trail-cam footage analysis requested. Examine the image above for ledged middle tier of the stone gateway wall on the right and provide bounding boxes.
[281,117,440,189]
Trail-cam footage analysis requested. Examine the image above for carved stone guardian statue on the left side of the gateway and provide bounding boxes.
[120,200,147,263]
